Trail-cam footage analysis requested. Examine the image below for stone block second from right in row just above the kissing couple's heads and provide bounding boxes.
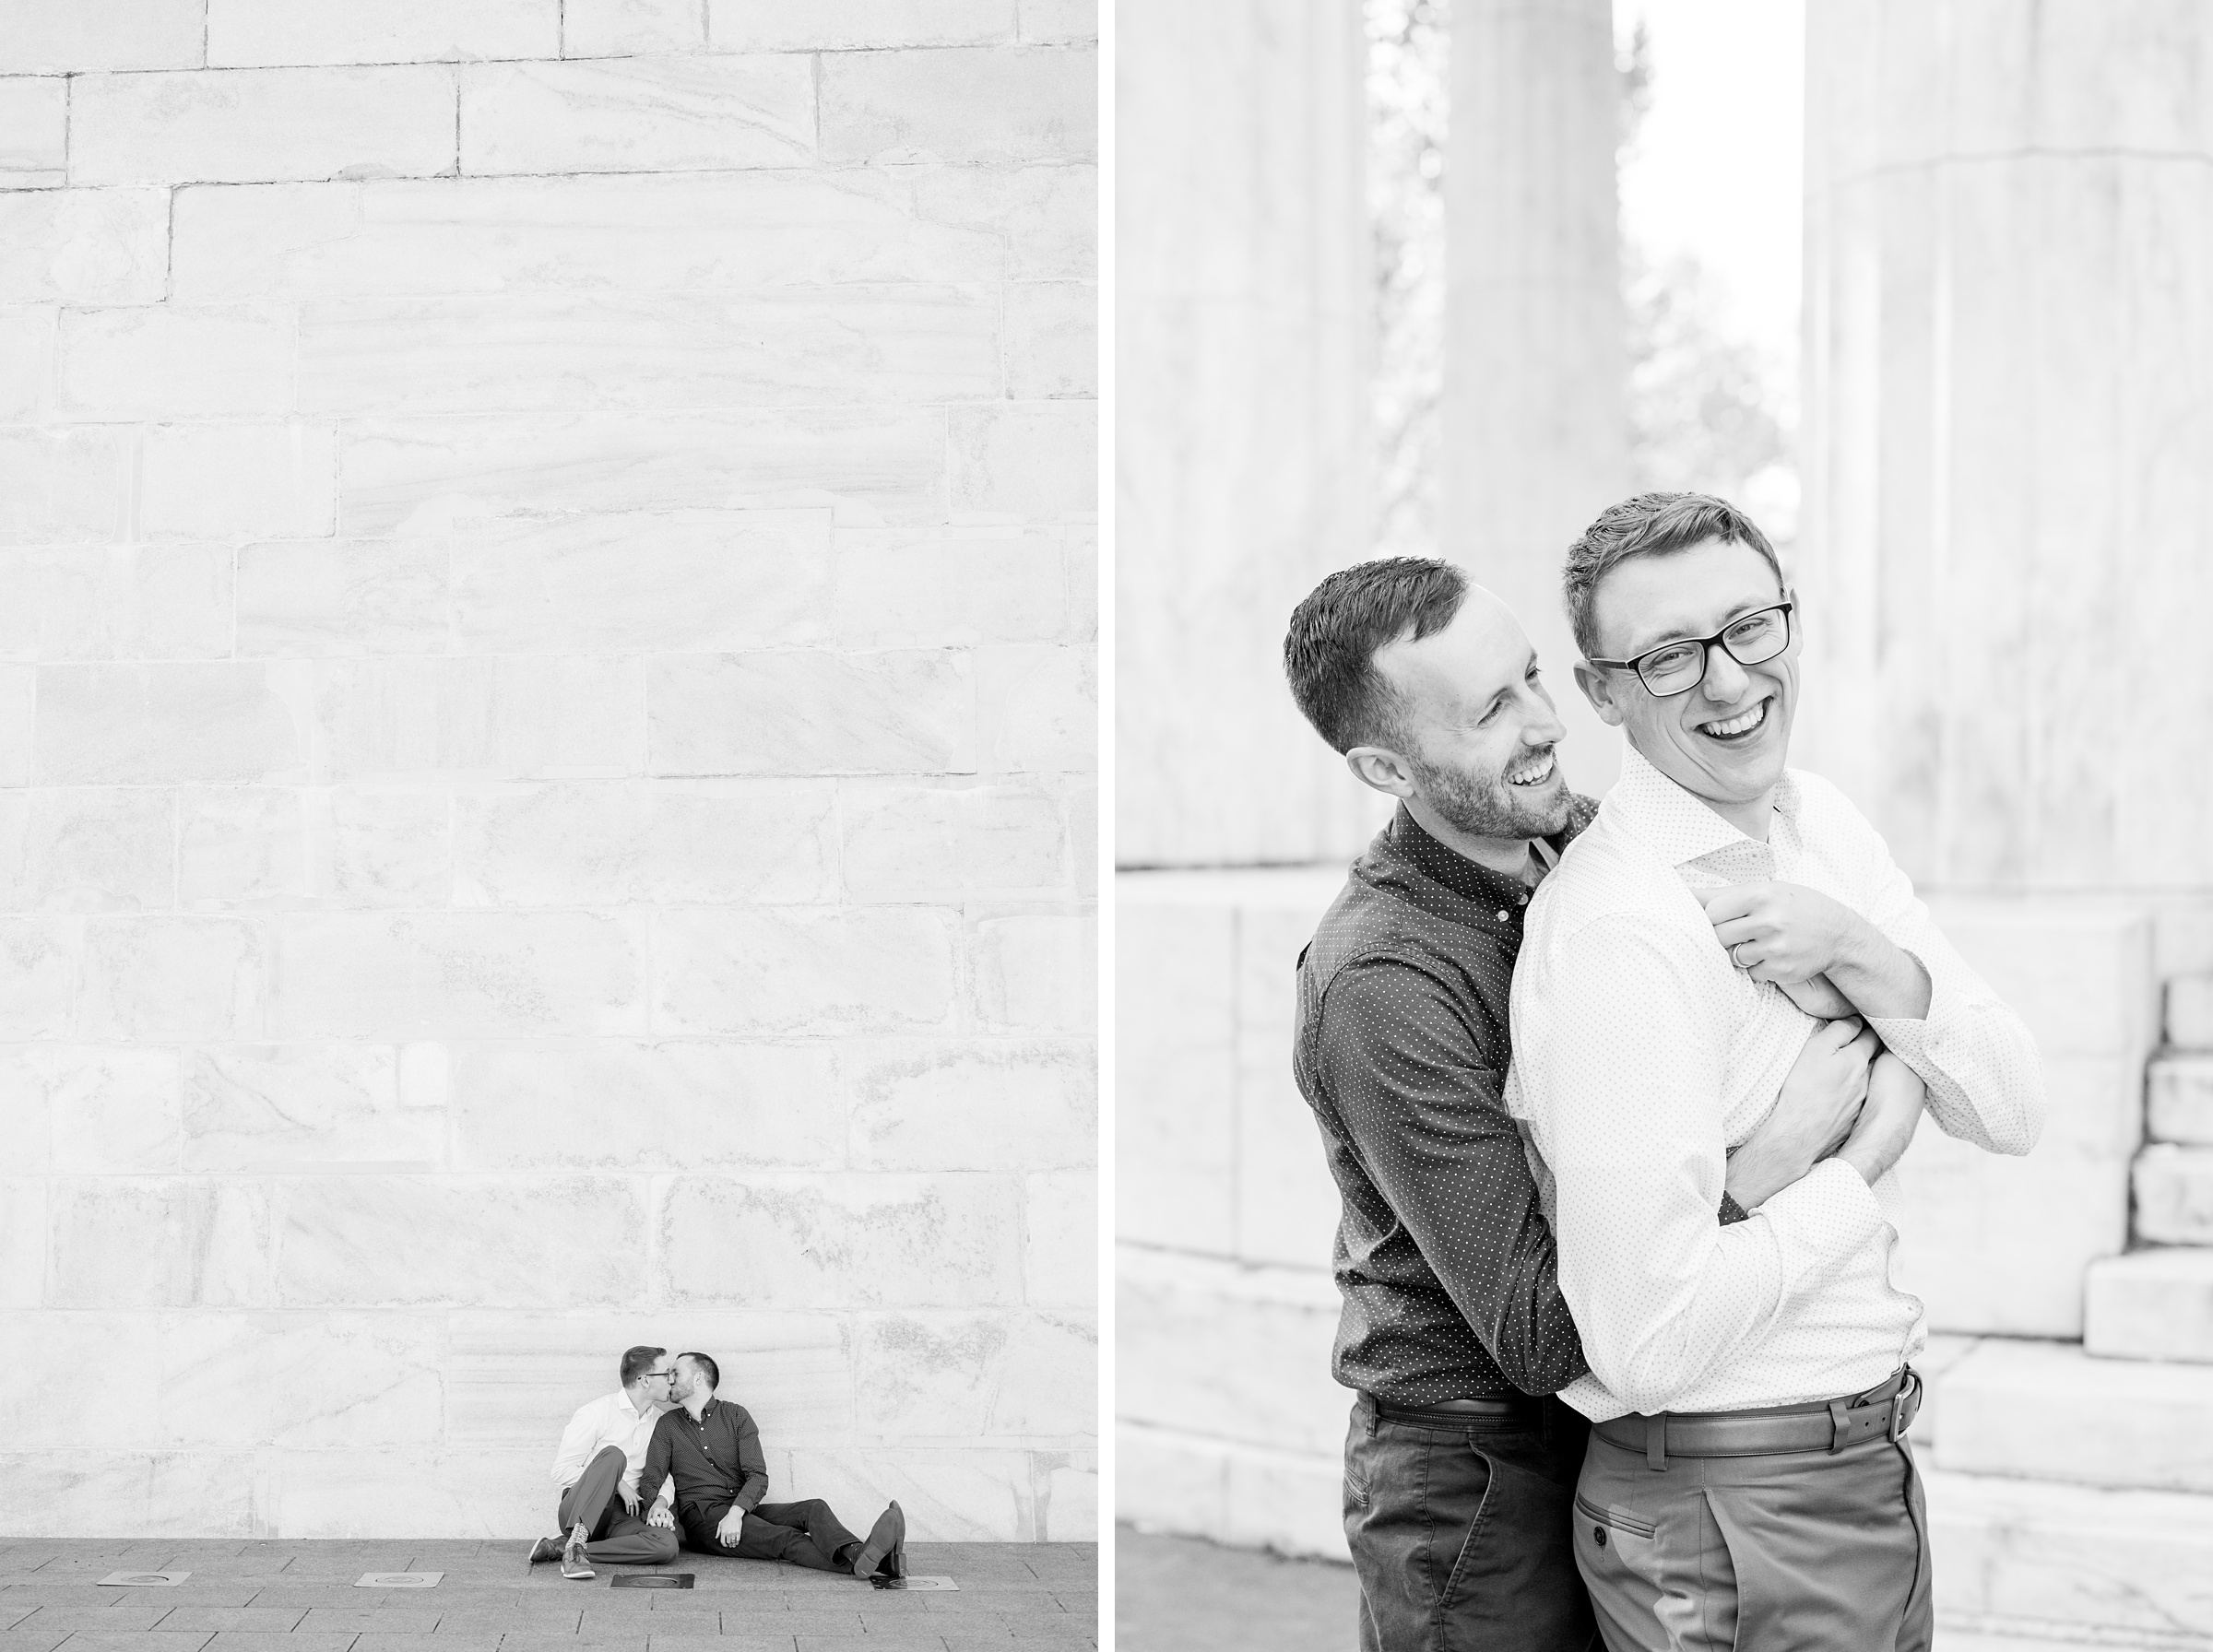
[653,1174,1023,1309]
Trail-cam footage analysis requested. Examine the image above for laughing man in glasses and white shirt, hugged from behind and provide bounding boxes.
[1507,493,2045,1652]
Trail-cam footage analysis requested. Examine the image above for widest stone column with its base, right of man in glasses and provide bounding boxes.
[1799,0,2213,1336]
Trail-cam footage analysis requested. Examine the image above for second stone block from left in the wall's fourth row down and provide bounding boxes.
[55,305,297,420]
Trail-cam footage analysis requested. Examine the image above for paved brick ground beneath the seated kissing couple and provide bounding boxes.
[0,1537,1097,1652]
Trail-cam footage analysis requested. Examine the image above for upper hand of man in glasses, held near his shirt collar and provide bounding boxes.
[1698,882,1930,1020]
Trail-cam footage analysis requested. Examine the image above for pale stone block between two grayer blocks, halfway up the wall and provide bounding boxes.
[316,655,644,781]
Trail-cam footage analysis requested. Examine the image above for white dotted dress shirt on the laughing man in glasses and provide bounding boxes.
[1505,749,2045,1420]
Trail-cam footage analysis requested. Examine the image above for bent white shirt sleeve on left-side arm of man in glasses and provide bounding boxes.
[1516,915,1886,1411]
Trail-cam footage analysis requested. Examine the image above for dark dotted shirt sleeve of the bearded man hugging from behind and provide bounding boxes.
[1317,960,1593,1393]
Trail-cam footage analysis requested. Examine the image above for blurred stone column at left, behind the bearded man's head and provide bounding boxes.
[1116,0,1377,867]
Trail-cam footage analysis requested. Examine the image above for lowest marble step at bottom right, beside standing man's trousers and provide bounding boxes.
[1925,1477,2213,1652]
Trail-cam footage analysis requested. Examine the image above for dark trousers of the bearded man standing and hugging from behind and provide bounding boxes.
[1345,1393,1598,1652]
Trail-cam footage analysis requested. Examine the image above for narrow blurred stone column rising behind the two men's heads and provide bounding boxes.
[1438,0,1628,794]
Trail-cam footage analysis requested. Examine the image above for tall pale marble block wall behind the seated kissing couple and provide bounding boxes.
[0,0,1095,1540]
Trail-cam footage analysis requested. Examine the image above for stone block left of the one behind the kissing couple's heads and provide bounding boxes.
[157,1314,444,1448]
